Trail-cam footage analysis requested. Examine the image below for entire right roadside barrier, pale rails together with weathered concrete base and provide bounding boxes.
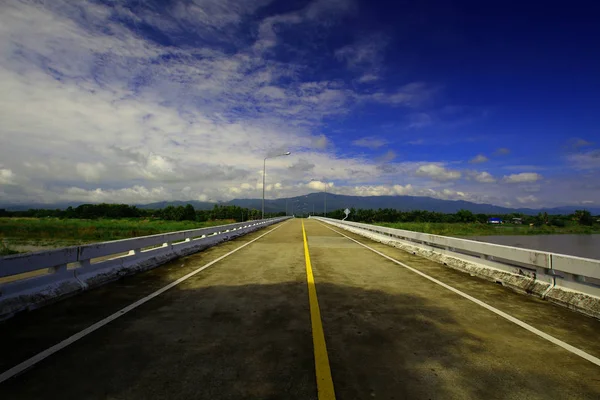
[311,217,600,319]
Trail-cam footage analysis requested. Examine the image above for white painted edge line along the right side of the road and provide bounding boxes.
[319,222,600,366]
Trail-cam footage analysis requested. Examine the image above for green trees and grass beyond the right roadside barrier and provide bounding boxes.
[327,209,600,236]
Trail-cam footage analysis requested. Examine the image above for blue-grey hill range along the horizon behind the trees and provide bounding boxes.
[0,192,600,215]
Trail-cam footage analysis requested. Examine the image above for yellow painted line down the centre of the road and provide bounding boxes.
[302,221,335,400]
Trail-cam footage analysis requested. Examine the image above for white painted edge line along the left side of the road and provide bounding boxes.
[0,220,290,383]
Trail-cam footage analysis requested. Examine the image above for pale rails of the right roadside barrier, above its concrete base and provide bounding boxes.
[312,217,600,297]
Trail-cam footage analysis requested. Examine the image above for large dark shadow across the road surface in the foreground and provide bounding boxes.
[0,278,599,399]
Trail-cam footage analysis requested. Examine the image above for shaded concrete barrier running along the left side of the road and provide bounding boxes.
[0,217,291,320]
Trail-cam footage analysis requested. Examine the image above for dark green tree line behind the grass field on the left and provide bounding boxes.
[0,203,285,222]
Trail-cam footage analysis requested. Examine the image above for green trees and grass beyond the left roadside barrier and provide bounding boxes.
[0,204,285,256]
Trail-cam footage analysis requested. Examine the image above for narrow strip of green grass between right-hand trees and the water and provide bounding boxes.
[374,222,600,236]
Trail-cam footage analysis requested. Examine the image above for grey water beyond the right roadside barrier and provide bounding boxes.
[465,235,600,260]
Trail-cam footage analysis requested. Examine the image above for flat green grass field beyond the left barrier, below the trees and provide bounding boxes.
[0,218,239,256]
